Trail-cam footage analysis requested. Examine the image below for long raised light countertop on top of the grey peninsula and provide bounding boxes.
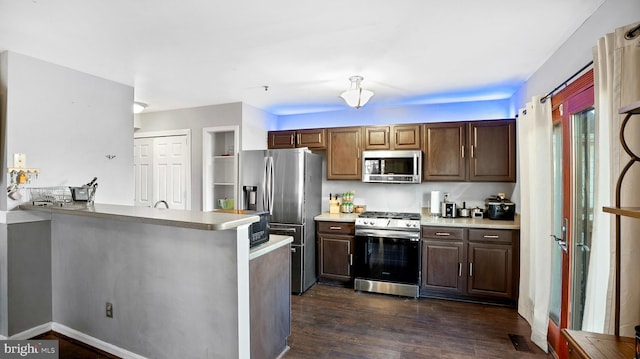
[19,203,260,231]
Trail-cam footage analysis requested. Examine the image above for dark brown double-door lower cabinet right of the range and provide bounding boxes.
[420,226,519,305]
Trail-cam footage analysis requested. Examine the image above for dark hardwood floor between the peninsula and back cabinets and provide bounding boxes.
[284,284,551,359]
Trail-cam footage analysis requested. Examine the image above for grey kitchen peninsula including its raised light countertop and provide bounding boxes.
[15,204,291,358]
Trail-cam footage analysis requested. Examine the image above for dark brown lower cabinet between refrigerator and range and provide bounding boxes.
[317,222,355,286]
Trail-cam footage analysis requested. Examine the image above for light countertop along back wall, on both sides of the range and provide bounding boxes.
[314,212,520,229]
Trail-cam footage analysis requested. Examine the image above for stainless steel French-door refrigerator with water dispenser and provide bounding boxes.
[238,148,322,294]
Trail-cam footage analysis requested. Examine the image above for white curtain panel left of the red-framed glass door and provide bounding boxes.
[517,97,553,352]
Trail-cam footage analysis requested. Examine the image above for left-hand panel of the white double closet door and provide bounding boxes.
[133,138,153,207]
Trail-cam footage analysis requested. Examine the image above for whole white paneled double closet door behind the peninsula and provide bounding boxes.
[133,132,191,209]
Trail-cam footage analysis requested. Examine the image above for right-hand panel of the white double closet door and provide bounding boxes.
[153,136,188,209]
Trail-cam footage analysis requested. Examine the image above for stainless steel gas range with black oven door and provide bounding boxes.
[354,212,422,297]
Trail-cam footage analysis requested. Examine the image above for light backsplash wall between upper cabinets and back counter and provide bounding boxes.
[322,152,519,212]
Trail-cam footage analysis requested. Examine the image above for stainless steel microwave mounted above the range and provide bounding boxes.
[362,151,422,183]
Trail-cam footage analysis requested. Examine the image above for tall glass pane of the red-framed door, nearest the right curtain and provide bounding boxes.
[570,108,595,330]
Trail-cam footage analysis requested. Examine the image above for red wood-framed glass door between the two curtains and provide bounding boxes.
[547,71,595,359]
